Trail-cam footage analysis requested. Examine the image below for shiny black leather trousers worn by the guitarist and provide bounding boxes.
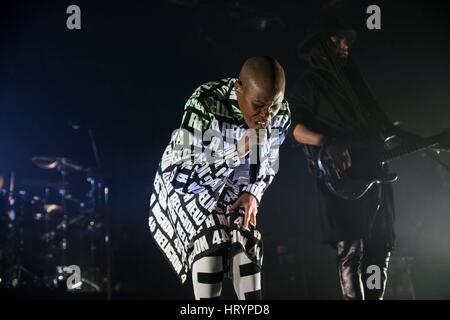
[336,240,390,300]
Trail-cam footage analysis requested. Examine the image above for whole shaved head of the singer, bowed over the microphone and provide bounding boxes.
[235,56,285,129]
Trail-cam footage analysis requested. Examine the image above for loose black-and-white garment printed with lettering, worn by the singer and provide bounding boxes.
[149,78,290,283]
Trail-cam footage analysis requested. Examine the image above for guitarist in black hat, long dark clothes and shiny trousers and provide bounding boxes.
[289,22,418,299]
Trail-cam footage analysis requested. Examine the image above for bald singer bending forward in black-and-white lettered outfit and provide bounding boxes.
[149,56,290,300]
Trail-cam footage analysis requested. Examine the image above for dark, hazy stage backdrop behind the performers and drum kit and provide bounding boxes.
[0,0,450,299]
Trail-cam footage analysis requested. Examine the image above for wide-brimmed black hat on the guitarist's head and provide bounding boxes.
[298,18,356,57]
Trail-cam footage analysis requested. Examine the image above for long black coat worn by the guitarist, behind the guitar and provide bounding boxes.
[288,62,395,247]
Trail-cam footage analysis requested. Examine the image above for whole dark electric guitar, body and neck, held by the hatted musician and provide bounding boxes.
[316,128,450,200]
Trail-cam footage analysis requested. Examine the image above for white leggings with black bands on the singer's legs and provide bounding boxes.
[192,250,261,300]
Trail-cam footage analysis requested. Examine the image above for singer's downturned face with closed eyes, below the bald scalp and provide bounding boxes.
[236,81,284,129]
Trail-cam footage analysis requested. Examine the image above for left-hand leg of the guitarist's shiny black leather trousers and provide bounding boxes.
[336,240,364,300]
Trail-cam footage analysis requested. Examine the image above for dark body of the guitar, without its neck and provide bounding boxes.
[317,144,398,200]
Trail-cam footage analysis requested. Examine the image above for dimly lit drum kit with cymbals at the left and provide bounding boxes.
[0,157,108,292]
